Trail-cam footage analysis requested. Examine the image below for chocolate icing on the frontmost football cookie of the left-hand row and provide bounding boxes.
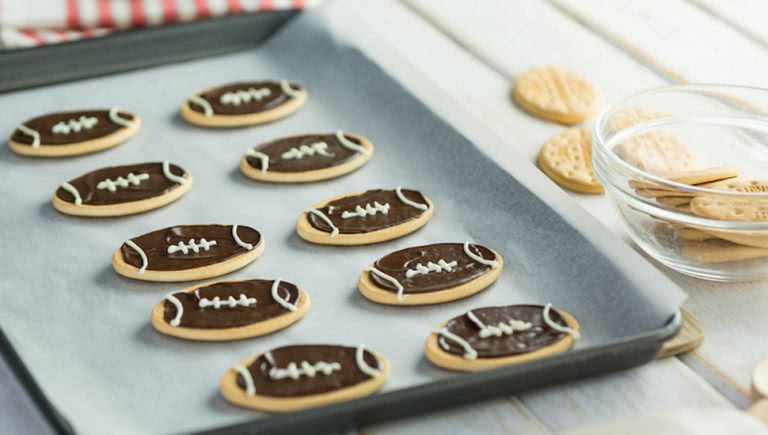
[237,345,379,397]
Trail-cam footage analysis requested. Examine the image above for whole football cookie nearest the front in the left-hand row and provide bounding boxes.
[221,344,389,412]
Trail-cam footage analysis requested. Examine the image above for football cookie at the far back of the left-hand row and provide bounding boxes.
[8,107,141,157]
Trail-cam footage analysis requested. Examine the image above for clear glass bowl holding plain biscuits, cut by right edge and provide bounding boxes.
[593,85,768,281]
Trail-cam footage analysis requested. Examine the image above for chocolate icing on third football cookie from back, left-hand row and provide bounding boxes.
[120,225,261,271]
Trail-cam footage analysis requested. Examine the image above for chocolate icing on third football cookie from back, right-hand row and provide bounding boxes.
[307,189,427,234]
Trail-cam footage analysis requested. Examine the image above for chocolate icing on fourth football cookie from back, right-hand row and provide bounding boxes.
[368,243,496,294]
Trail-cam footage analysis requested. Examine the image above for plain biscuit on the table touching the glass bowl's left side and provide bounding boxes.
[539,128,603,194]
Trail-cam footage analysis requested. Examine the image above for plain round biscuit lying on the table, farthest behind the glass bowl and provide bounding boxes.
[512,66,601,125]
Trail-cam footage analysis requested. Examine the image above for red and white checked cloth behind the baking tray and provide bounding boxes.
[0,0,321,48]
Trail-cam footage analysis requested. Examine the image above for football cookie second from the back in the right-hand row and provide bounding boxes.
[240,130,373,183]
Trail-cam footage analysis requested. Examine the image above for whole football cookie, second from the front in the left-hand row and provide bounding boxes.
[152,279,309,341]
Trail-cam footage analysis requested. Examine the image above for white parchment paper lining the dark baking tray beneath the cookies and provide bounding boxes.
[0,4,684,434]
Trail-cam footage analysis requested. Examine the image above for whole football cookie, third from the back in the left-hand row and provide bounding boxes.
[112,225,264,282]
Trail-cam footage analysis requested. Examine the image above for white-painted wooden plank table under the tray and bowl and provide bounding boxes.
[0,0,768,435]
